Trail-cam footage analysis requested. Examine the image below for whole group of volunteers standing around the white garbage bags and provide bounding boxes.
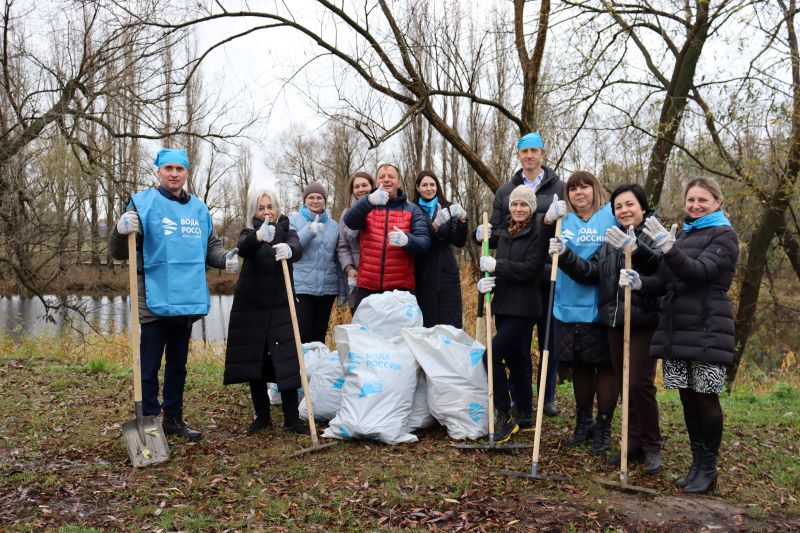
[109,132,738,493]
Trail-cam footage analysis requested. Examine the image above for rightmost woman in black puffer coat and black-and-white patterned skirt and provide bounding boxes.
[619,178,739,493]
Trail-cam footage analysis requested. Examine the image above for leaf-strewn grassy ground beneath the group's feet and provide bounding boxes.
[0,330,800,531]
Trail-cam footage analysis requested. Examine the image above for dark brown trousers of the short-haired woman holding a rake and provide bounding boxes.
[608,328,662,452]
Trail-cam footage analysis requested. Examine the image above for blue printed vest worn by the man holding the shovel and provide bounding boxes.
[131,189,213,316]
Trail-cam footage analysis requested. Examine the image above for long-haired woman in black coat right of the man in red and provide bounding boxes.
[414,170,467,329]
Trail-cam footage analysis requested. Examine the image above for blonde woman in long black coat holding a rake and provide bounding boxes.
[224,189,308,433]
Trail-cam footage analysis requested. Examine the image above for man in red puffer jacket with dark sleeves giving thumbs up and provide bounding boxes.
[344,163,431,308]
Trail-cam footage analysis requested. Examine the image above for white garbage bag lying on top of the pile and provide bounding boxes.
[354,291,422,334]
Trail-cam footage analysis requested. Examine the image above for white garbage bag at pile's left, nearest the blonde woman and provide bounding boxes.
[297,342,344,422]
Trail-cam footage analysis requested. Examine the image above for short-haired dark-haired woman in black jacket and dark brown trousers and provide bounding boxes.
[558,184,662,473]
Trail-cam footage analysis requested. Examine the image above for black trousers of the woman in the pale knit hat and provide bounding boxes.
[492,315,536,414]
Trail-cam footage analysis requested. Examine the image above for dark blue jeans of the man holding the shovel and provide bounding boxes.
[140,319,192,418]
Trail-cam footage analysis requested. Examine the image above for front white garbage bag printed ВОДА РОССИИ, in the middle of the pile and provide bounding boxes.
[323,324,419,444]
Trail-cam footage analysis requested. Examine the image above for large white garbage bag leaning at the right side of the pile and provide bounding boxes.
[402,325,489,440]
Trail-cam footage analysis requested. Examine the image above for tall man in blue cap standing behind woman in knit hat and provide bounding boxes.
[474,132,565,424]
